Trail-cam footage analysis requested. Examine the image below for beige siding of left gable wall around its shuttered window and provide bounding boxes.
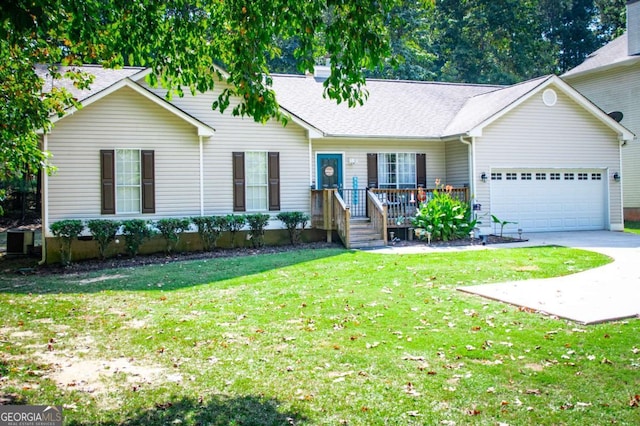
[48,87,200,230]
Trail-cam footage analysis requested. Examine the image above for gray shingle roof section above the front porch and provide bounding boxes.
[273,75,502,138]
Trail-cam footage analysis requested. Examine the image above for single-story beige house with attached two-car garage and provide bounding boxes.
[38,62,633,262]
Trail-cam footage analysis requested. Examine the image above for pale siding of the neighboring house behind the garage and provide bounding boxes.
[567,63,640,208]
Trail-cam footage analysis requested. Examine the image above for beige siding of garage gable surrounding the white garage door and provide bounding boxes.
[475,84,622,226]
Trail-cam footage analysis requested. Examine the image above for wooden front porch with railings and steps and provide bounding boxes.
[311,187,469,248]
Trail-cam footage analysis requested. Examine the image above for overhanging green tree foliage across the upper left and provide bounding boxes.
[0,0,397,213]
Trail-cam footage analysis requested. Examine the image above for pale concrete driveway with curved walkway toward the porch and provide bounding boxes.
[380,231,640,324]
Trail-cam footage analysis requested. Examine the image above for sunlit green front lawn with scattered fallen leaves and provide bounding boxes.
[0,247,640,425]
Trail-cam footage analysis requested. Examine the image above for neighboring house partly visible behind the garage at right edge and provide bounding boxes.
[562,0,640,220]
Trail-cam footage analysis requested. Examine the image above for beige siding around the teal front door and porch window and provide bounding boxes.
[312,139,446,188]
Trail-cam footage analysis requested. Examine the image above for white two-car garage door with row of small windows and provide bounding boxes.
[489,169,607,233]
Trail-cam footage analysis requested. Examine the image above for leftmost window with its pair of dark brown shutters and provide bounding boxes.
[100,149,155,214]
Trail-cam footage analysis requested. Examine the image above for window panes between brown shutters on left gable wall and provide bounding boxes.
[116,149,141,213]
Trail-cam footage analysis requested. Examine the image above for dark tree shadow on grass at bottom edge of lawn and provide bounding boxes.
[64,395,307,426]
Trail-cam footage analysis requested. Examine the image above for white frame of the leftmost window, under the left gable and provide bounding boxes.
[114,148,142,214]
